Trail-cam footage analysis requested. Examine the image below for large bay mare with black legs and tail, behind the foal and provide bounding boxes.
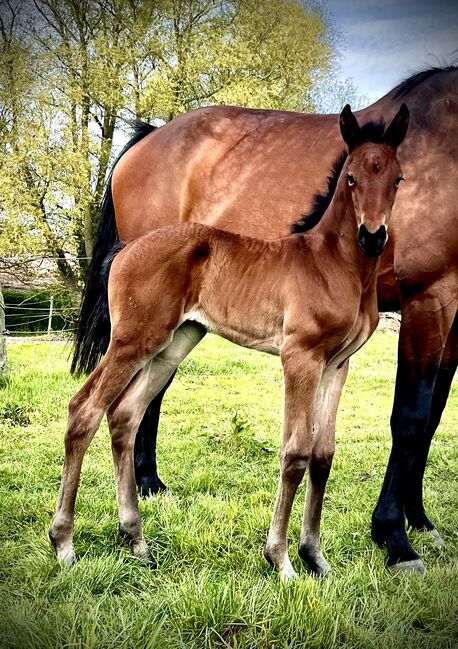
[72,66,458,572]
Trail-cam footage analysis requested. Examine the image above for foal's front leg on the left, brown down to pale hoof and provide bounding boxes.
[264,345,322,580]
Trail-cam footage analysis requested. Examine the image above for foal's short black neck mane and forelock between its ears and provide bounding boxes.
[291,121,385,234]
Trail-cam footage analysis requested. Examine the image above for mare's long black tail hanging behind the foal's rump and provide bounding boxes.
[70,122,156,375]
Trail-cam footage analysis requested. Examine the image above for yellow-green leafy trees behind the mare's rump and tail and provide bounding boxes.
[0,0,334,296]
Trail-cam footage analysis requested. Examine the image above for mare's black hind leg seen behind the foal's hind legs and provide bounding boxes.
[134,371,176,498]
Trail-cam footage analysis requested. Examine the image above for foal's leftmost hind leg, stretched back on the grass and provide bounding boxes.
[49,343,151,565]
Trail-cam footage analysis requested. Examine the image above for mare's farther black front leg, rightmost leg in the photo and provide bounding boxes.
[405,318,458,545]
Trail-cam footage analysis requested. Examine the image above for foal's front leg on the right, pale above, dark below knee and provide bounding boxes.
[299,360,348,576]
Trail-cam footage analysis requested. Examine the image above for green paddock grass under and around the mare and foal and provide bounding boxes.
[0,332,458,649]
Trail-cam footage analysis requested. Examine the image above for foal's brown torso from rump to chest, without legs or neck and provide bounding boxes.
[109,223,360,353]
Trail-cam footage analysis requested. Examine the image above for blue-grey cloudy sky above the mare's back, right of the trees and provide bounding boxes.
[326,0,458,103]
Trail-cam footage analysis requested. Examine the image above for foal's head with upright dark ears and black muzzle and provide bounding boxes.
[340,104,409,257]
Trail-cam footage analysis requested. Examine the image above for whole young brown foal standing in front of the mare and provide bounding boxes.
[50,105,409,579]
